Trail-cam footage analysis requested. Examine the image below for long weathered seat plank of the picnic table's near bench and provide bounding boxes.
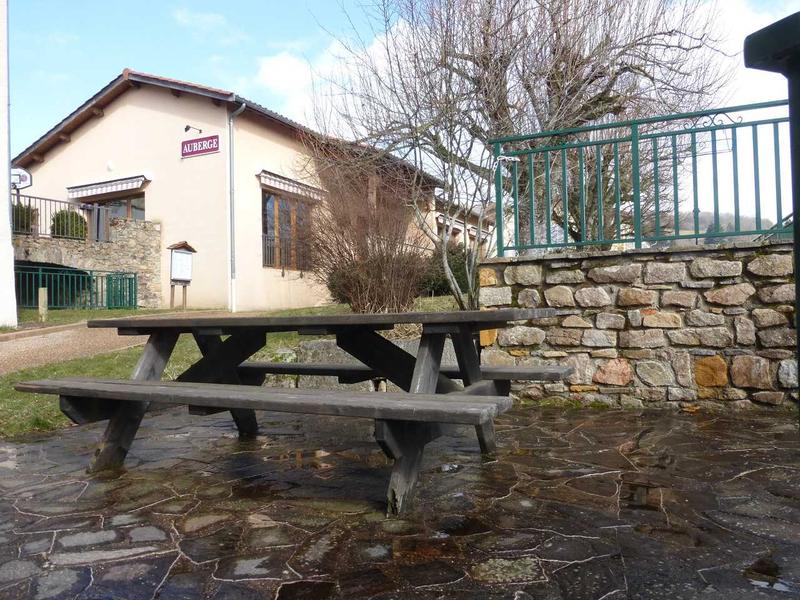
[15,378,512,425]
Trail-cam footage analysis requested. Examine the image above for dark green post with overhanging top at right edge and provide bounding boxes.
[744,12,800,426]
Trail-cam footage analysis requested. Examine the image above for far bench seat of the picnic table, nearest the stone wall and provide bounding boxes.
[237,361,572,394]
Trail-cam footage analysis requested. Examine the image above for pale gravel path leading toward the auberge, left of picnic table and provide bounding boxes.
[0,324,146,375]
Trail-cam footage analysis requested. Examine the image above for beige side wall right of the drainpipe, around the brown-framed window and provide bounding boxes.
[234,113,329,310]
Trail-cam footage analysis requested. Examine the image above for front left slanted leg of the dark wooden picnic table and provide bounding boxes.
[88,331,178,473]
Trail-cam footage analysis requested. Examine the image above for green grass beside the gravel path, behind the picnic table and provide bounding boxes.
[0,297,455,438]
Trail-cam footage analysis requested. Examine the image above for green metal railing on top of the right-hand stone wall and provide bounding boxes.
[490,100,791,256]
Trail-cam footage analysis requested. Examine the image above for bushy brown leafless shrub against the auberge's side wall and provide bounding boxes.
[303,135,433,313]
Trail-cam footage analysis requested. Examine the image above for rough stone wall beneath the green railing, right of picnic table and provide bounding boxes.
[480,242,797,409]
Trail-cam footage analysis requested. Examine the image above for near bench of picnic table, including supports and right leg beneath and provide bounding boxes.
[15,378,512,514]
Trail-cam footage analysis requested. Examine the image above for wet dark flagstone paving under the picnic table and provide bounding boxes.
[0,408,800,600]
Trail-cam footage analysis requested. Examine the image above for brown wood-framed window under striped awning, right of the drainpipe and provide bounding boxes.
[261,192,311,271]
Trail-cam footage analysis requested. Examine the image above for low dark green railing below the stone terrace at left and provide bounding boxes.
[14,265,138,308]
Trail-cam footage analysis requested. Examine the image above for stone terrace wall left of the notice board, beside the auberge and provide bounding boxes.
[13,219,161,308]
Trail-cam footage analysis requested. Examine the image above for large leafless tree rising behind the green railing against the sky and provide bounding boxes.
[310,0,725,308]
